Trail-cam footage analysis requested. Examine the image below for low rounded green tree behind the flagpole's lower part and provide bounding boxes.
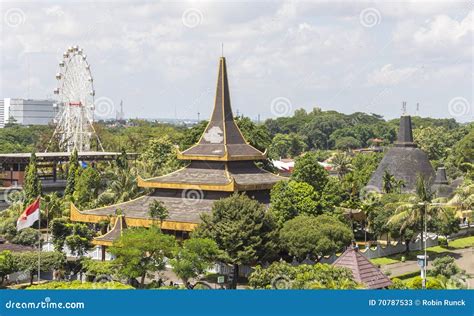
[13,251,66,285]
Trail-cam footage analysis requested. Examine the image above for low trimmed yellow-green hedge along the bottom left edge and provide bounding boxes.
[26,281,133,290]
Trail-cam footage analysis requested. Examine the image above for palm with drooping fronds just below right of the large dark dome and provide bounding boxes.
[387,175,452,251]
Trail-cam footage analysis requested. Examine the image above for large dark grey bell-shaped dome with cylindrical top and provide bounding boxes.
[368,115,435,193]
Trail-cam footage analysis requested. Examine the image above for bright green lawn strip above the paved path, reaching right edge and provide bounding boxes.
[370,236,474,266]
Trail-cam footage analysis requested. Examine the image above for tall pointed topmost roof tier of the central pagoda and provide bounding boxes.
[180,57,265,160]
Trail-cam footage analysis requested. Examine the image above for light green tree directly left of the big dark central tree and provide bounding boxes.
[170,238,219,284]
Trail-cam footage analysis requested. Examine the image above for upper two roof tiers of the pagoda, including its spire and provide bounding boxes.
[139,57,282,192]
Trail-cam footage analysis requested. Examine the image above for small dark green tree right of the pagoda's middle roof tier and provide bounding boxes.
[291,152,329,192]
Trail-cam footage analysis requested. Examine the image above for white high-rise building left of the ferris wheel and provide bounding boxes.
[0,98,56,128]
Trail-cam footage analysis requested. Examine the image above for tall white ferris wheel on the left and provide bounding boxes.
[53,46,103,152]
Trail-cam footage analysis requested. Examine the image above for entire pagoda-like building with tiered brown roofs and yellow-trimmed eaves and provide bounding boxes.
[71,57,285,252]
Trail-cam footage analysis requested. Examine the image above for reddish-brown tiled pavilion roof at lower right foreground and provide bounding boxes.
[333,247,392,289]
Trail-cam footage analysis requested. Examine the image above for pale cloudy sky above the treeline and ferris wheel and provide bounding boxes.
[0,0,474,122]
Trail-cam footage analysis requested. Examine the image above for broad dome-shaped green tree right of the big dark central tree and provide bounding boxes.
[280,215,354,261]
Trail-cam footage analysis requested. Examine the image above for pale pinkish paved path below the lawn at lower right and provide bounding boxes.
[382,247,474,289]
